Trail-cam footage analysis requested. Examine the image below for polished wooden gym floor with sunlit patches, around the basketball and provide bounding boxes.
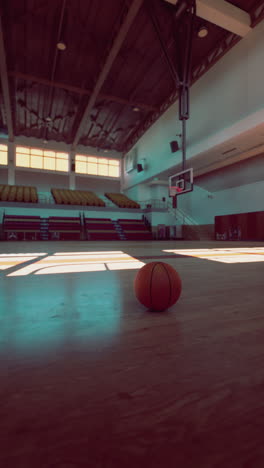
[0,241,264,468]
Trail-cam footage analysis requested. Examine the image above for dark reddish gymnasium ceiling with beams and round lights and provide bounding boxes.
[0,0,264,153]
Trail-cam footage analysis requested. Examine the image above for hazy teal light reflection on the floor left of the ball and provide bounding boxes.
[0,265,125,354]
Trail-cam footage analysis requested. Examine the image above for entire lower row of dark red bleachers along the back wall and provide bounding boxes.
[3,215,152,240]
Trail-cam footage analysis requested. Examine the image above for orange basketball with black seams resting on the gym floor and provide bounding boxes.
[134,262,182,311]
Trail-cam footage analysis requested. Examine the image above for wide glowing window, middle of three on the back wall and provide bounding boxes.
[16,146,69,172]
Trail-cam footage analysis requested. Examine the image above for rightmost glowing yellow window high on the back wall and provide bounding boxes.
[75,154,120,177]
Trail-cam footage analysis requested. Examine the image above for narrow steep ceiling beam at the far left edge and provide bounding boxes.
[0,13,14,141]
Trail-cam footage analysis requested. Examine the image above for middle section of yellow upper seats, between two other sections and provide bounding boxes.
[51,188,105,206]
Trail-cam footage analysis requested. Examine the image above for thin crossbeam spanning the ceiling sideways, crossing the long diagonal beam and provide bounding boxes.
[8,71,157,112]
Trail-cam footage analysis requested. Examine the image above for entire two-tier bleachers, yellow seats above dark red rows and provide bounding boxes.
[0,185,155,241]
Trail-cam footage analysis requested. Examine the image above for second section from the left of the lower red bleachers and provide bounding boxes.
[48,216,81,240]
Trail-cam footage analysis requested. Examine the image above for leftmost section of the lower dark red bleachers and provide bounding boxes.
[3,215,41,240]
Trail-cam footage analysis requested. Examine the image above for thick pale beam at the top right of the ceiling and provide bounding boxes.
[165,0,251,37]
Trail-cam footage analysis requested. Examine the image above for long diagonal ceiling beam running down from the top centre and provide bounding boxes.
[72,0,143,150]
